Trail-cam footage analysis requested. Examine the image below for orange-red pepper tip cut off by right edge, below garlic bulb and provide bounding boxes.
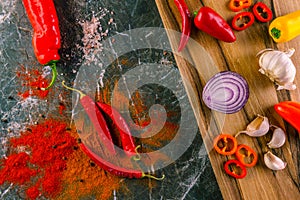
[274,101,300,133]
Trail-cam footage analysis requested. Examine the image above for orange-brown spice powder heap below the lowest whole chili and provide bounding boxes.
[56,130,122,200]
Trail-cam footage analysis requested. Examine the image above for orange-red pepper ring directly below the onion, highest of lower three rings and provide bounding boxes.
[214,134,237,155]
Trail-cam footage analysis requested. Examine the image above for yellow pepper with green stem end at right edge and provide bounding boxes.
[269,10,300,43]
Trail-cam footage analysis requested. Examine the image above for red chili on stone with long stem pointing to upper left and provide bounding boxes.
[62,81,116,155]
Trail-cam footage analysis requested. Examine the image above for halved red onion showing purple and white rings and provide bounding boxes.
[202,71,249,114]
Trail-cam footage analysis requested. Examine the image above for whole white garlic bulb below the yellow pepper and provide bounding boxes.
[257,49,296,90]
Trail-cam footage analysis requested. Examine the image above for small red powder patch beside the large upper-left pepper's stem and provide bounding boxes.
[17,66,49,99]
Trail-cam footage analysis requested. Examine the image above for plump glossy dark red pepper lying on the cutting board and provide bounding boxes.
[194,6,236,42]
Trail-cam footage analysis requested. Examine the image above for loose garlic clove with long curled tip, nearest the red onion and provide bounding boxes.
[236,115,270,137]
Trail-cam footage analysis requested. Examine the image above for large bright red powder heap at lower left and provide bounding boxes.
[0,119,77,199]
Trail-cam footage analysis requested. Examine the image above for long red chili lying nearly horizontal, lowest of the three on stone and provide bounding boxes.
[79,143,165,180]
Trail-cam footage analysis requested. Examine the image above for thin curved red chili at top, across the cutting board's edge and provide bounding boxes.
[174,0,192,52]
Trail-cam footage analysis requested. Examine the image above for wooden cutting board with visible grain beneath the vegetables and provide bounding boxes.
[156,0,300,200]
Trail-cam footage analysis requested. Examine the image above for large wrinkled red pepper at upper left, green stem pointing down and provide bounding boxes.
[23,0,61,90]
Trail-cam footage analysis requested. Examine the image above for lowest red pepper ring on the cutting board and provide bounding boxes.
[224,160,247,179]
